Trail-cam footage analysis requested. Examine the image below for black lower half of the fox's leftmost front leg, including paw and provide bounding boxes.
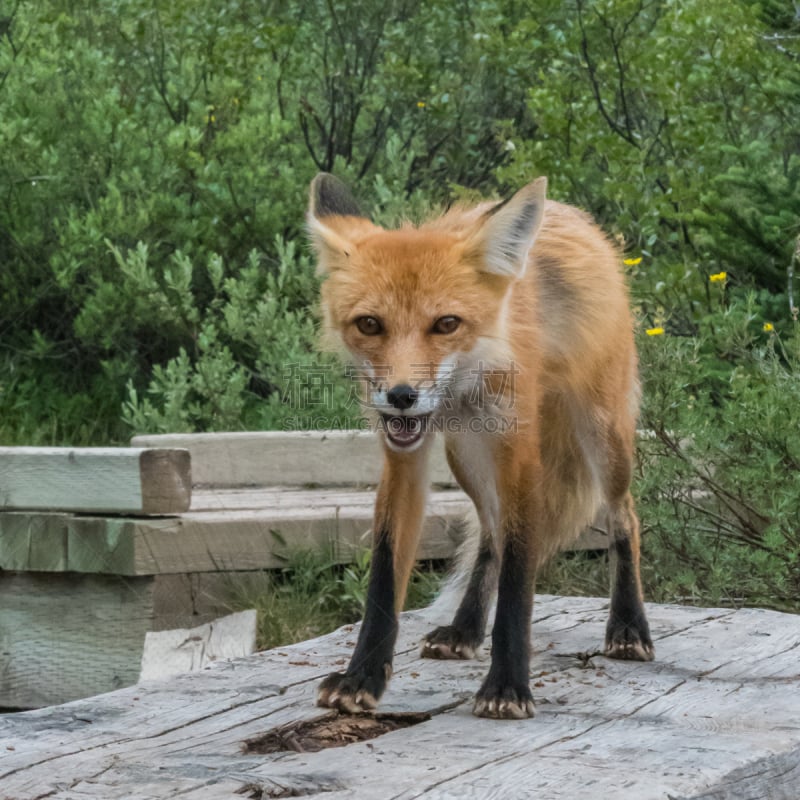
[317,532,397,713]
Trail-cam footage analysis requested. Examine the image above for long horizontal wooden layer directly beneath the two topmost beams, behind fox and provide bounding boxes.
[0,493,464,575]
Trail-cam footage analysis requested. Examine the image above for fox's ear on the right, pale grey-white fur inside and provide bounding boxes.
[467,178,547,278]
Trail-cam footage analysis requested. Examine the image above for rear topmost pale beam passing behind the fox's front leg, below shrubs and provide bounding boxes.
[131,430,455,487]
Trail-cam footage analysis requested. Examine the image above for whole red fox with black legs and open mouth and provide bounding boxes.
[308,173,654,719]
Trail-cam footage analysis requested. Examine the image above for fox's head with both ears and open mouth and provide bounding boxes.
[308,173,546,452]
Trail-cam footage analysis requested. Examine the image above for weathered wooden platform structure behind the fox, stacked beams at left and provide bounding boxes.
[0,431,606,708]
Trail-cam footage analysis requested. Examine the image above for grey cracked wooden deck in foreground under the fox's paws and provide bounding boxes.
[0,597,800,800]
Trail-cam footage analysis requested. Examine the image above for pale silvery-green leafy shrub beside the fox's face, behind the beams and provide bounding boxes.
[116,241,358,433]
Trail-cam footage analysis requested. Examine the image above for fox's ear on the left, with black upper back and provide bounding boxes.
[307,172,372,274]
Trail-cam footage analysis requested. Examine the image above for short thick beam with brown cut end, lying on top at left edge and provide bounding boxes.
[0,447,192,514]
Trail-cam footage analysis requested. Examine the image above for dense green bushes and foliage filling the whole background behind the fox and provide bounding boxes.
[0,0,800,602]
